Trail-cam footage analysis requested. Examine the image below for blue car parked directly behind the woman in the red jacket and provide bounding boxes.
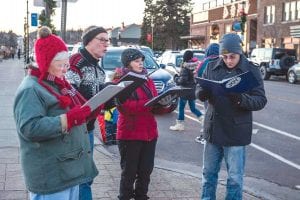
[99,47,178,112]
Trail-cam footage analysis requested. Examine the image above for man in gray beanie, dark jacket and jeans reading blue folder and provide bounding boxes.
[196,33,267,200]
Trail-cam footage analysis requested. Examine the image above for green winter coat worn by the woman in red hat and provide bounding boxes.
[14,76,98,194]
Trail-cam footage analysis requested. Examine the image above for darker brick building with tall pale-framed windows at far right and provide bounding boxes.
[257,0,300,55]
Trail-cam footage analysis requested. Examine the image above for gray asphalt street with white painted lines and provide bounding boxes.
[108,73,300,199]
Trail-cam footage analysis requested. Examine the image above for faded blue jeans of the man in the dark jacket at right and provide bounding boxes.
[201,142,246,200]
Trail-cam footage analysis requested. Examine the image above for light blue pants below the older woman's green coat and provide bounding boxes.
[29,185,79,200]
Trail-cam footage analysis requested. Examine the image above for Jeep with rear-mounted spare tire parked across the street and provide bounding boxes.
[249,48,297,80]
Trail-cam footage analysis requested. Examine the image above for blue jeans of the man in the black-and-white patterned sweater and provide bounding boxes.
[79,130,94,200]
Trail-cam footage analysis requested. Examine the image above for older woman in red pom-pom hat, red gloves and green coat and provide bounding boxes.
[13,27,98,200]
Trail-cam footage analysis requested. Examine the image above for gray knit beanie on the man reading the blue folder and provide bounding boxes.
[220,33,243,55]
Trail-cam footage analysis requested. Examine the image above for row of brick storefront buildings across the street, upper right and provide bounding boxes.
[190,0,300,55]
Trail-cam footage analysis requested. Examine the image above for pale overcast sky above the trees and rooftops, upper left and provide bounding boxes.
[0,0,145,35]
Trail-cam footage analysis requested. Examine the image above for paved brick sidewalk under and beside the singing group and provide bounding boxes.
[0,59,265,200]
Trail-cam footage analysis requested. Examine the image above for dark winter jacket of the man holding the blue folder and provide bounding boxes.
[203,55,267,146]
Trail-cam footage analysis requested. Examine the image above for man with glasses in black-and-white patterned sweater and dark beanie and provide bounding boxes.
[66,26,109,200]
